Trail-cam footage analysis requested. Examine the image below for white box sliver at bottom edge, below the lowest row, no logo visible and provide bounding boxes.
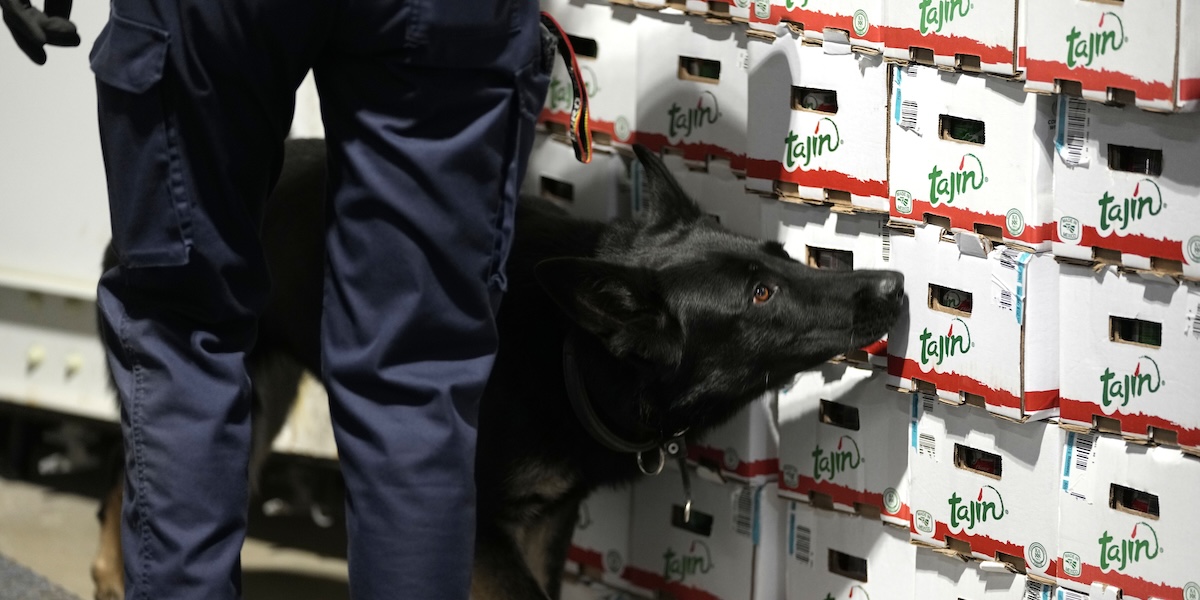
[916,550,1055,600]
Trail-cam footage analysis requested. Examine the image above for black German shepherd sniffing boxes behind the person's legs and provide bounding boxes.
[94,140,905,600]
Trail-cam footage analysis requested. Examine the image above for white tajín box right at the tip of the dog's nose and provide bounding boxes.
[888,226,1058,420]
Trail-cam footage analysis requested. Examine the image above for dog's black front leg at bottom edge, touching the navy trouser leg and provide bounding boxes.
[470,520,550,600]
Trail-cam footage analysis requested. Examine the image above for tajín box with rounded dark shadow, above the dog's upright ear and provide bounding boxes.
[626,11,749,173]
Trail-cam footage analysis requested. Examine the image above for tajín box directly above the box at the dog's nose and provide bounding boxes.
[888,64,1054,251]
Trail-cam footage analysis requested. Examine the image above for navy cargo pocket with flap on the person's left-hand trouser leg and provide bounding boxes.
[91,13,188,268]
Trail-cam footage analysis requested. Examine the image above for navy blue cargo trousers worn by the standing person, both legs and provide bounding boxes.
[91,0,548,600]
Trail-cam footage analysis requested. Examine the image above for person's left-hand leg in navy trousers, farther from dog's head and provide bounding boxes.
[91,0,329,600]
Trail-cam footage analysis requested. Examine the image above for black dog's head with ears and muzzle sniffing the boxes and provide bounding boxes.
[536,146,904,426]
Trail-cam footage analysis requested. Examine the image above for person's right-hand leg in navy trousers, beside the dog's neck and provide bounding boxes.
[314,0,548,599]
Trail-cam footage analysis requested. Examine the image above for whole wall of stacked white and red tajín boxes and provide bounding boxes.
[540,0,1200,600]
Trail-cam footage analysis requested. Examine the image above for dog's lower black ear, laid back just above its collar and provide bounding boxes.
[534,258,683,365]
